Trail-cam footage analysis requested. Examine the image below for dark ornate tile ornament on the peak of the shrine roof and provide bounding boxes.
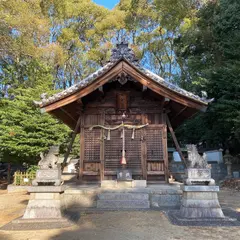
[110,41,138,64]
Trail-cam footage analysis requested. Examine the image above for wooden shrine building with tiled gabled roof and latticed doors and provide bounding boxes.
[36,43,208,182]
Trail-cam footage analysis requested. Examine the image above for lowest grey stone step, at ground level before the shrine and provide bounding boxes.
[97,200,150,209]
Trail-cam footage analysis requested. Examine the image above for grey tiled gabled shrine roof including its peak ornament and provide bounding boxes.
[35,43,211,112]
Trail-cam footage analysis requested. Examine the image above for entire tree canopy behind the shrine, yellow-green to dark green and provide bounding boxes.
[0,0,240,161]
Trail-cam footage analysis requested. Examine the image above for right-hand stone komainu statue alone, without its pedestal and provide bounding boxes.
[187,144,208,168]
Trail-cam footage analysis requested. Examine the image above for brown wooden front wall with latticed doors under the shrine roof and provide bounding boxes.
[80,81,168,181]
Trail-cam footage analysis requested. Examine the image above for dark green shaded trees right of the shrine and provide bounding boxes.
[176,0,240,151]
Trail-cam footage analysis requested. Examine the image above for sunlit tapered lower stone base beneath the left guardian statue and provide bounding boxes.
[22,186,65,220]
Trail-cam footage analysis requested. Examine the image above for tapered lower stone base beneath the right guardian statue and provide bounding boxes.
[179,185,224,220]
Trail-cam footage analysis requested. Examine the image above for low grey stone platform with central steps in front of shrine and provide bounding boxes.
[62,184,182,209]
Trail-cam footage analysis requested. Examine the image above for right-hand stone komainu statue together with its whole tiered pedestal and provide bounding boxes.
[179,145,224,220]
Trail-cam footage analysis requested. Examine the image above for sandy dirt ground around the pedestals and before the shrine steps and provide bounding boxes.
[0,190,240,240]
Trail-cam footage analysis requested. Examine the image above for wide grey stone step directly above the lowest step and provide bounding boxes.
[98,192,149,201]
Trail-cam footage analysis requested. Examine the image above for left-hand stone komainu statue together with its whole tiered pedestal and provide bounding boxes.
[22,146,65,221]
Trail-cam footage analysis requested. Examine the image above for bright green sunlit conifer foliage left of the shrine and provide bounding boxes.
[0,61,68,163]
